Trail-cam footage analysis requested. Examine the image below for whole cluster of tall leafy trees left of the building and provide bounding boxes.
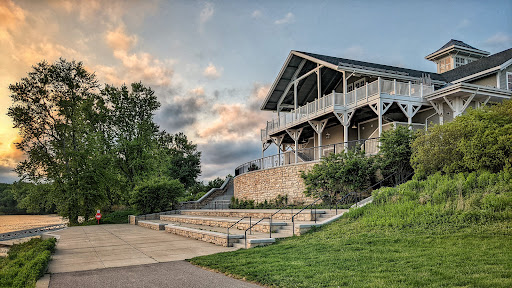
[8,59,201,222]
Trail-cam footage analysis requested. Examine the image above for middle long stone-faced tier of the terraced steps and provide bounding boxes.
[160,215,287,232]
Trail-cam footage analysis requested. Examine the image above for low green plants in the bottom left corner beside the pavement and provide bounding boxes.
[0,238,56,287]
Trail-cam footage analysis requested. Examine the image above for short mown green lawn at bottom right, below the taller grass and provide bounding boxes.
[190,219,512,287]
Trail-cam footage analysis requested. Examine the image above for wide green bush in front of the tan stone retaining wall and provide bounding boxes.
[301,150,376,204]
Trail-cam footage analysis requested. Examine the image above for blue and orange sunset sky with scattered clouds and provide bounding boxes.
[0,0,512,183]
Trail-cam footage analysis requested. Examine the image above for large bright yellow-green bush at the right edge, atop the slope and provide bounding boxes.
[411,100,512,177]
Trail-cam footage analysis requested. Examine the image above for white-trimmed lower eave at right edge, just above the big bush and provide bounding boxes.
[425,83,512,101]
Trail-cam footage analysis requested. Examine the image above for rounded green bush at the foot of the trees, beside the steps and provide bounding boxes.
[131,178,185,214]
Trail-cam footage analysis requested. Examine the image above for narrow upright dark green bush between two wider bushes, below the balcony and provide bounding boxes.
[377,126,414,186]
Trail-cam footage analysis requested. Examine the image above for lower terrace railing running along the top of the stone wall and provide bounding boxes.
[235,138,379,176]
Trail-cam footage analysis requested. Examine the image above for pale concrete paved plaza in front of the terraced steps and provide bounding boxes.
[49,224,236,274]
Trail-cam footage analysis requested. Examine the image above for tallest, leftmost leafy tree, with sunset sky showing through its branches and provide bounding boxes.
[8,59,104,223]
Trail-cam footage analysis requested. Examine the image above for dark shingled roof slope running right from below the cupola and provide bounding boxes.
[441,48,512,82]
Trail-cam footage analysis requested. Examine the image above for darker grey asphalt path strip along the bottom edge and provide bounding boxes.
[50,261,261,288]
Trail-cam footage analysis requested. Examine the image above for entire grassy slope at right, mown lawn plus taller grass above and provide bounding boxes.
[191,174,512,287]
